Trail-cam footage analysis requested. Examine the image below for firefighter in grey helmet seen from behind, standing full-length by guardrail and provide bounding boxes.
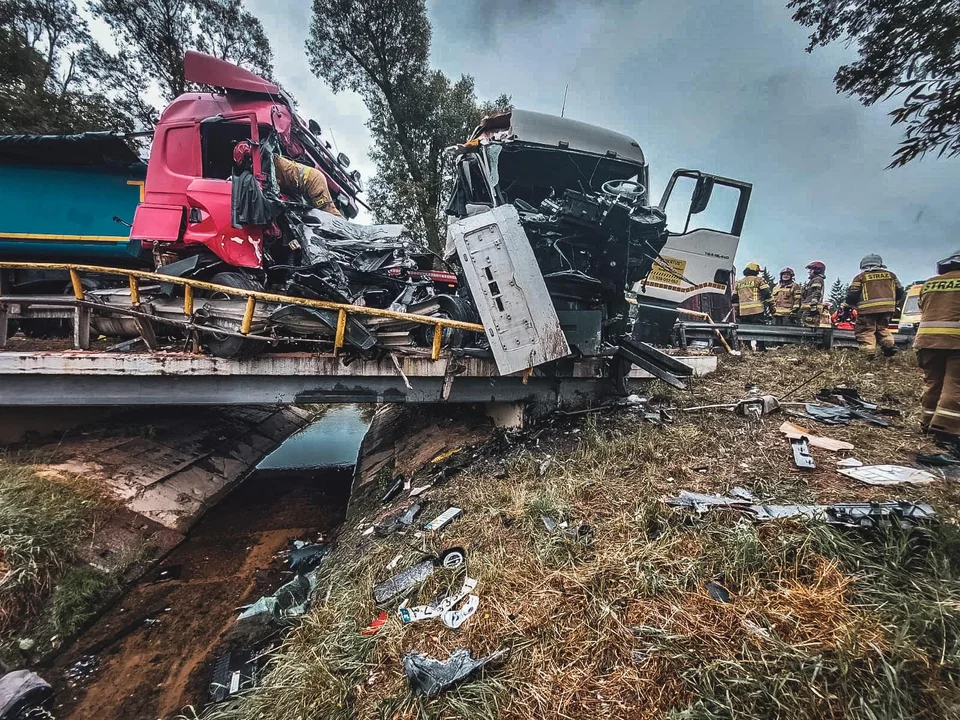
[844,254,903,357]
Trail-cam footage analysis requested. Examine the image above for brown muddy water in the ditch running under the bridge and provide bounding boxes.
[47,406,366,720]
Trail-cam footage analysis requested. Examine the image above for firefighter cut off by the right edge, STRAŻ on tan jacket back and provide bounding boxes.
[913,250,960,443]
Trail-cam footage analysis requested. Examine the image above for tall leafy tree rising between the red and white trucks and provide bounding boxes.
[307,0,509,251]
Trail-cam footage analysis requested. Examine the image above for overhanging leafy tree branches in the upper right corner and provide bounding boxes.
[787,0,960,167]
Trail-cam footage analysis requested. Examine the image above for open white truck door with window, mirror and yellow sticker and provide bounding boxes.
[634,170,753,306]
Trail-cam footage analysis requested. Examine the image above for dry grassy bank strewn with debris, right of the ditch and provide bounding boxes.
[206,350,960,720]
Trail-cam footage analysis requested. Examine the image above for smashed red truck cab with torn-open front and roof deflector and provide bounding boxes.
[130,51,361,269]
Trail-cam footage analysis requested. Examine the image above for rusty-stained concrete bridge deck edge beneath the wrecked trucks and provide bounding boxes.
[0,350,716,407]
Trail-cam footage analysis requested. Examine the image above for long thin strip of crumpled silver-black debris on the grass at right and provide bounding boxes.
[666,490,934,527]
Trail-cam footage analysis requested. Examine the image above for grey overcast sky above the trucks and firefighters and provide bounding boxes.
[247,0,960,283]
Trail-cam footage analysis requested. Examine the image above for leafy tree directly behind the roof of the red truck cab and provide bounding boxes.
[90,0,273,125]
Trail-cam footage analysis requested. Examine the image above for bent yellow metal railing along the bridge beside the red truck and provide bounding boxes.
[0,262,486,360]
